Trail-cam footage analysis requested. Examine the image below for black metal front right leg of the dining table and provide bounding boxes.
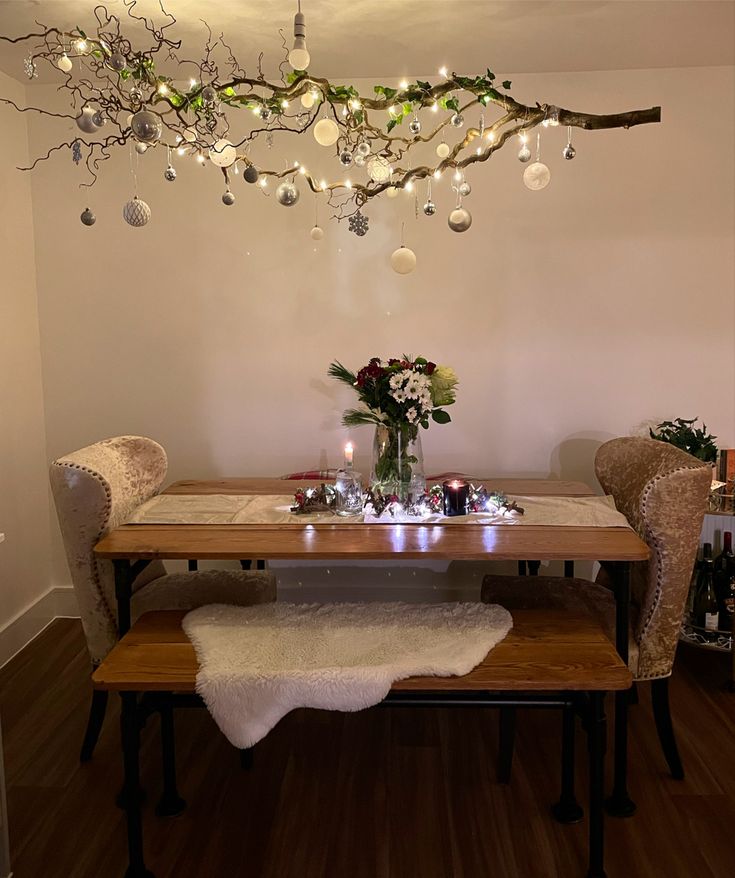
[605,561,635,817]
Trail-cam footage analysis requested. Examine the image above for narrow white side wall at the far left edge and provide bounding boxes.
[0,73,50,632]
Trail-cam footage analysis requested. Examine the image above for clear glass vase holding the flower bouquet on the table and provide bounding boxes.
[370,422,426,503]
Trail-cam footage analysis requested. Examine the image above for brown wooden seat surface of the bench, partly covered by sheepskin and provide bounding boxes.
[92,610,632,692]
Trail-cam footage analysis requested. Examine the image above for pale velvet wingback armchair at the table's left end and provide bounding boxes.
[50,436,276,761]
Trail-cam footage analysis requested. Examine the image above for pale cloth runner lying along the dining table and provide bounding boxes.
[128,494,629,527]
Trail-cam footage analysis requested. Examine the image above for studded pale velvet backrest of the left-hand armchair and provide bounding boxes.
[50,436,167,664]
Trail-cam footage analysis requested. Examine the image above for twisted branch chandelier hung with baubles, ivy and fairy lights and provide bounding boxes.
[0,0,661,274]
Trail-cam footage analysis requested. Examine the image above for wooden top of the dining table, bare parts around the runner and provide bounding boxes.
[95,478,649,561]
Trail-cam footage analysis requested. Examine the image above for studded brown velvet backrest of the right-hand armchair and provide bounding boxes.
[595,437,712,679]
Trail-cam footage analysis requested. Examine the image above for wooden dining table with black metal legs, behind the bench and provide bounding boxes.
[95,477,649,816]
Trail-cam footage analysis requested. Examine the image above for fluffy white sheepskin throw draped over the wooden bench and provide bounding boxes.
[183,603,513,747]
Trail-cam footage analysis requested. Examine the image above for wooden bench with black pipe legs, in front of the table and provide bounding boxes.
[92,610,632,878]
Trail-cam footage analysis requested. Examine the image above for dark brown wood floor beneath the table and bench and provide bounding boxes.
[0,620,735,878]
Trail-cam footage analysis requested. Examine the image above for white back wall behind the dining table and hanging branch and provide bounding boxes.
[6,67,735,600]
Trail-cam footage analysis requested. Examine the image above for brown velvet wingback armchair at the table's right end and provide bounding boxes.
[482,437,712,778]
